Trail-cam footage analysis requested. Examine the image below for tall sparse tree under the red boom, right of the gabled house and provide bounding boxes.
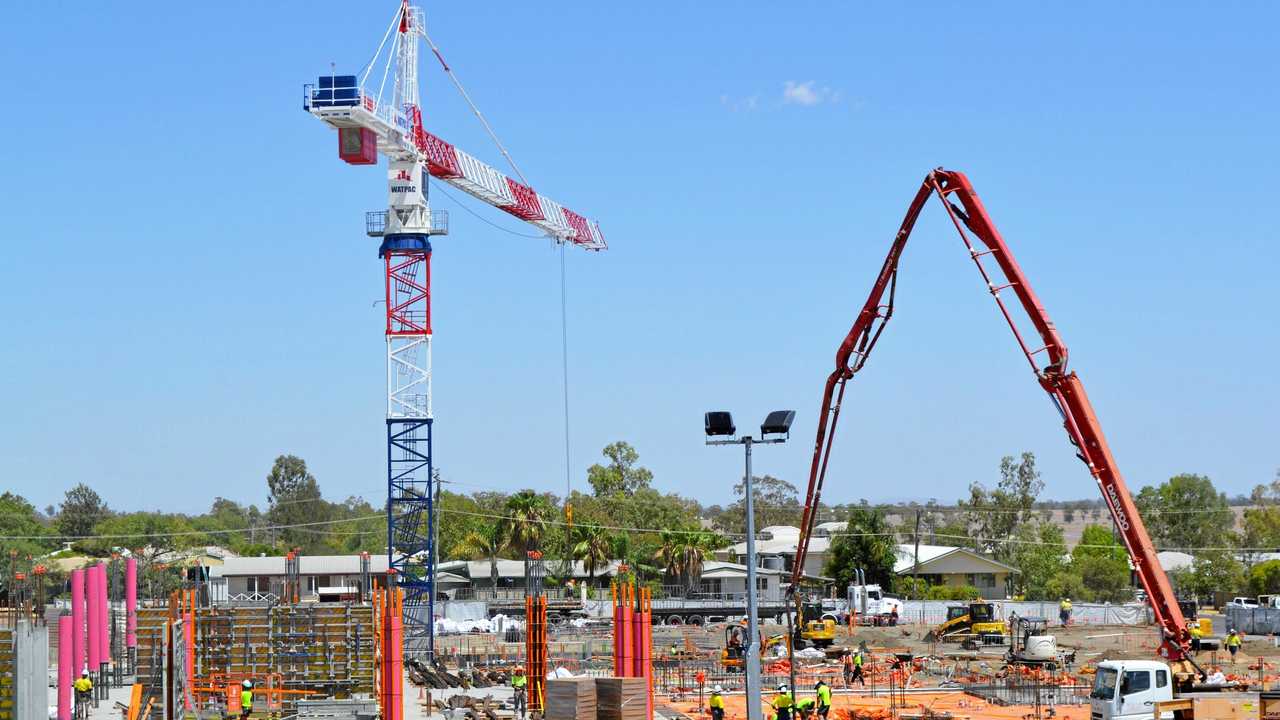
[959,452,1044,562]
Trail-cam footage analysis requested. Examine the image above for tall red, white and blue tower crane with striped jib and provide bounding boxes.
[302,0,607,653]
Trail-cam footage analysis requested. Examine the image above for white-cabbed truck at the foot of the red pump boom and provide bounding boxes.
[1089,660,1260,720]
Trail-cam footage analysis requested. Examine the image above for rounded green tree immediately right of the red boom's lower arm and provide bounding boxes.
[1134,474,1235,553]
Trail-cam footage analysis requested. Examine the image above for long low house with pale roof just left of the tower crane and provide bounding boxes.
[209,555,387,602]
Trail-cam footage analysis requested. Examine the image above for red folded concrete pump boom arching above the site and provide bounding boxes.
[791,168,1190,661]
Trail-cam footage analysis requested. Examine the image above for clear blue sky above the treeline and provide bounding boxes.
[0,3,1280,511]
